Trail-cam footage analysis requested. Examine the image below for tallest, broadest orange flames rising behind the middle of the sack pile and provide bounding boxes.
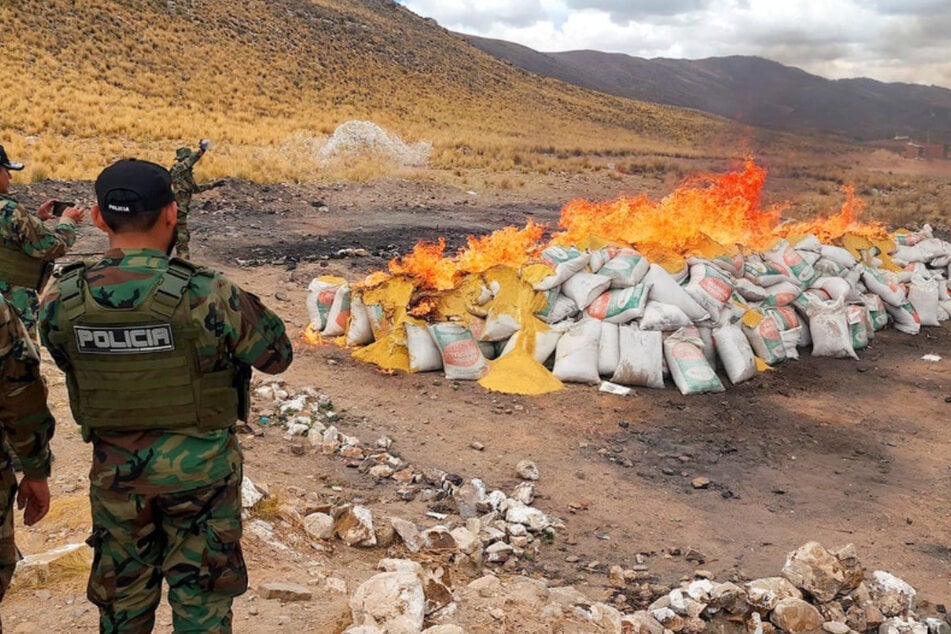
[553,160,782,256]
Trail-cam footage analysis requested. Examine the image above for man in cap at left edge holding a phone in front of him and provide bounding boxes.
[0,145,85,330]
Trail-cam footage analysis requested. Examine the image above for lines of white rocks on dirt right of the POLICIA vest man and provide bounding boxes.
[251,379,563,569]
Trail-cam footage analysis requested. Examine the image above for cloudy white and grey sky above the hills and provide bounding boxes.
[400,0,951,88]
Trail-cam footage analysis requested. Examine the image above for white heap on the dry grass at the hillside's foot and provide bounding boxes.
[317,121,432,167]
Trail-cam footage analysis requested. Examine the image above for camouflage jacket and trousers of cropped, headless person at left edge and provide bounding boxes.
[0,296,55,596]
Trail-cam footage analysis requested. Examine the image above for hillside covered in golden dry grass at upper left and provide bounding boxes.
[0,0,750,181]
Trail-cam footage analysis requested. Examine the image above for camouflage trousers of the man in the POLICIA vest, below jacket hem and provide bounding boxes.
[87,473,248,633]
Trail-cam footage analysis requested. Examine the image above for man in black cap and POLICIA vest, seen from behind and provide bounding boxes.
[40,159,292,632]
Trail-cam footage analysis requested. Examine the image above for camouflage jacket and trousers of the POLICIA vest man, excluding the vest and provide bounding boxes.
[40,249,292,632]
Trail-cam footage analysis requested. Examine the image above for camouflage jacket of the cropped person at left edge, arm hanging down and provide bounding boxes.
[0,296,56,479]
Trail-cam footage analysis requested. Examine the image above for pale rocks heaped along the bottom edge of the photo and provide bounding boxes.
[330,542,951,634]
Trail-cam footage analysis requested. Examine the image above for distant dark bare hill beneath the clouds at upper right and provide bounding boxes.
[461,35,951,143]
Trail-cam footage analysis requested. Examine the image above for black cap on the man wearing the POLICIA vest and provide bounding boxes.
[96,159,175,214]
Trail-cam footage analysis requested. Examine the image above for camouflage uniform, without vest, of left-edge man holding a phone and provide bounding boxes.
[0,194,76,330]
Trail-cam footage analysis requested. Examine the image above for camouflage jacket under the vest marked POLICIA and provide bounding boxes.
[40,249,293,495]
